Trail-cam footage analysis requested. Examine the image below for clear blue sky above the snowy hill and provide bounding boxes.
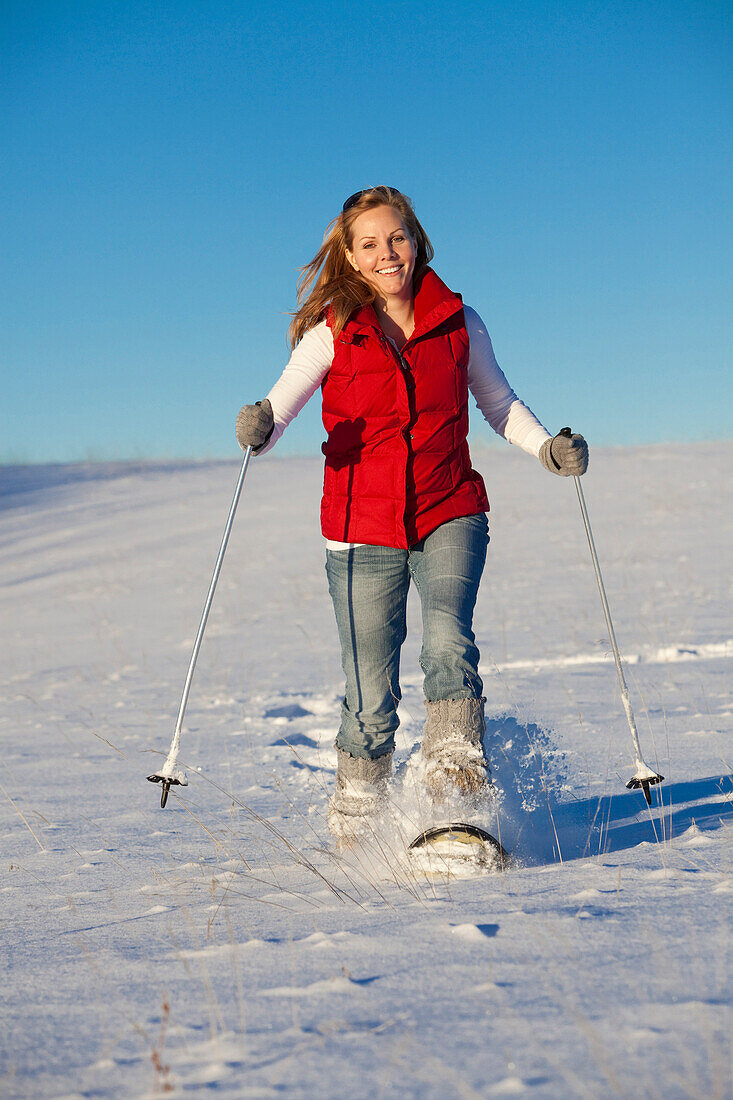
[0,0,733,462]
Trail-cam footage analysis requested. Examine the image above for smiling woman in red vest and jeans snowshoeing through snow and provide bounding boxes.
[237,187,588,843]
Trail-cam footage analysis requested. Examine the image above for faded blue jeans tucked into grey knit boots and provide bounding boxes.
[326,513,489,759]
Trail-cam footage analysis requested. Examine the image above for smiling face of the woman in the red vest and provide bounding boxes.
[347,206,417,298]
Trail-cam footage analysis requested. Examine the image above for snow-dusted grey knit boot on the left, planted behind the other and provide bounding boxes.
[328,748,392,847]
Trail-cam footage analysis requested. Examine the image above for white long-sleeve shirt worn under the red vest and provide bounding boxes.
[259,306,550,550]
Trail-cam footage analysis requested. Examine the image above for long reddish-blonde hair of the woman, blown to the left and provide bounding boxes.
[288,187,435,348]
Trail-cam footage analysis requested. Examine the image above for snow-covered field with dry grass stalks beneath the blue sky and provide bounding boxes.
[0,443,733,1100]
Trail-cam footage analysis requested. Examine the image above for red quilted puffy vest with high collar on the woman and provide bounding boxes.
[320,268,489,549]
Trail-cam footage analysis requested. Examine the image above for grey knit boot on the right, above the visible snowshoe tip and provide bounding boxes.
[423,699,491,801]
